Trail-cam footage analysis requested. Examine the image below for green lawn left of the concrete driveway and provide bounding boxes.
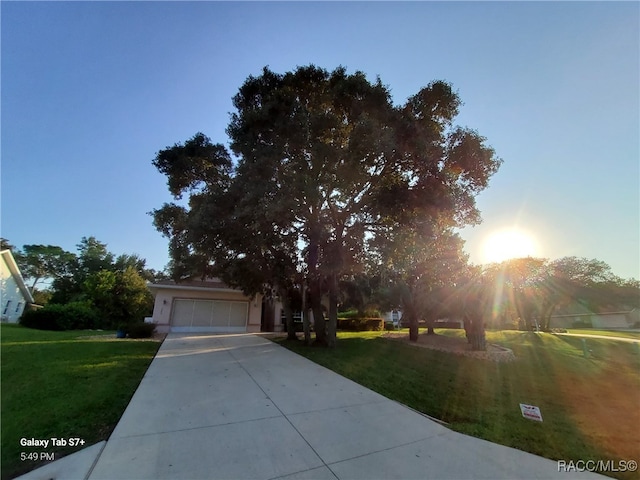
[0,324,160,479]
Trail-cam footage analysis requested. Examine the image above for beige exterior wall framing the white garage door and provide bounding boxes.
[151,287,262,333]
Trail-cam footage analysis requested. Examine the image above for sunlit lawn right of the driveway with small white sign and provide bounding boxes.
[278,330,640,480]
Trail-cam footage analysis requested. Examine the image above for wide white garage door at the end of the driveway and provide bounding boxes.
[171,299,249,333]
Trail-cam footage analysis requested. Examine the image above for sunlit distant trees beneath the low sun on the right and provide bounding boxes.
[340,253,640,335]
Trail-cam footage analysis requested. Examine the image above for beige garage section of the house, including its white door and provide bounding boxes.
[149,278,264,333]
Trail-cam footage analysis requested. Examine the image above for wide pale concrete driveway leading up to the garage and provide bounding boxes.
[21,334,603,480]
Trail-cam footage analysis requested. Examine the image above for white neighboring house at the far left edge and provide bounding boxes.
[0,250,33,323]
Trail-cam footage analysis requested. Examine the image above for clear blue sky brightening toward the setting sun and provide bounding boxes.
[0,1,640,278]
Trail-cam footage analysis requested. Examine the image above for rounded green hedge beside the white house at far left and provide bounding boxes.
[20,302,102,330]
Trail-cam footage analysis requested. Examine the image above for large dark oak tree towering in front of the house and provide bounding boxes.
[152,65,500,345]
